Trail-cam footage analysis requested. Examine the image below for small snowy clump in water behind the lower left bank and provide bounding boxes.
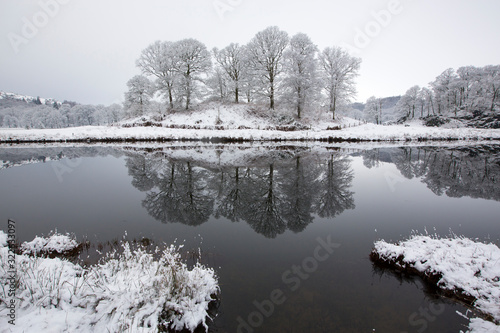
[21,232,79,254]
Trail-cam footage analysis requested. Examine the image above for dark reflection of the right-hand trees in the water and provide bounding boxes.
[362,145,500,201]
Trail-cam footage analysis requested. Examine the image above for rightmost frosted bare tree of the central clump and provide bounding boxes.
[319,47,361,119]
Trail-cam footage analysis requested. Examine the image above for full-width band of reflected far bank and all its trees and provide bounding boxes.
[0,145,500,238]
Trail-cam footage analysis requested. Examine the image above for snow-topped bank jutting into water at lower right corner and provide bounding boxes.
[371,236,500,333]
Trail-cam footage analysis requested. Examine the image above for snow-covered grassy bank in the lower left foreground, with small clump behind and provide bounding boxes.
[0,231,219,332]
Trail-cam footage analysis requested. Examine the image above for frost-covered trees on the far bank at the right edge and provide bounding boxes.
[398,65,500,119]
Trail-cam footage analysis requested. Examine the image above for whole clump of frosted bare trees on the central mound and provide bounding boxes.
[125,26,361,118]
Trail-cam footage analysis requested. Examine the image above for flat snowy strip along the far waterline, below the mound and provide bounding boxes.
[0,122,500,143]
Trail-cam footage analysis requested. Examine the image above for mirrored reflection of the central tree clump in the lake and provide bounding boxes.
[126,150,354,238]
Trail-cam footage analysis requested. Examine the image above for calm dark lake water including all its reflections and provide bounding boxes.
[0,145,500,332]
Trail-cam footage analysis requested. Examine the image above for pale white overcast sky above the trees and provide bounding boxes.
[0,0,500,105]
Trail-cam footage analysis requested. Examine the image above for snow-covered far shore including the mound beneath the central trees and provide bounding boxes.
[0,104,500,142]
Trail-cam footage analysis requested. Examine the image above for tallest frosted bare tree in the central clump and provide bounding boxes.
[248,26,289,110]
